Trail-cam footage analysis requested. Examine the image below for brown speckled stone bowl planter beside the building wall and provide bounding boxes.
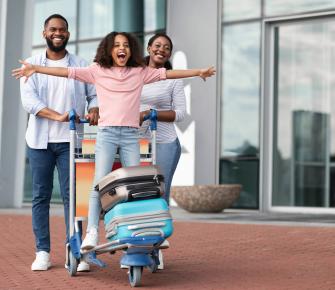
[171,184,242,213]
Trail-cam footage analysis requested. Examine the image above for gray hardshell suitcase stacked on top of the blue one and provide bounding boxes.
[95,165,164,212]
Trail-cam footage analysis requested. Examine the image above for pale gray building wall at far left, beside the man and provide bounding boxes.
[0,0,32,207]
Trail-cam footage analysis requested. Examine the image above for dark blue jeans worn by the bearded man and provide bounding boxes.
[28,143,70,252]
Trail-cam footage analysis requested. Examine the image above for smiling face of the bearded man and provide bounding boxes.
[43,18,70,52]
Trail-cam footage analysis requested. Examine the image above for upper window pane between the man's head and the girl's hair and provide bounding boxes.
[79,0,114,39]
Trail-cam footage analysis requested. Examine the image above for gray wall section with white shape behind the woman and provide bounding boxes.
[167,0,220,184]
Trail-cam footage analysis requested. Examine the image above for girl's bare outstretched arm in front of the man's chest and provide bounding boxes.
[12,60,68,81]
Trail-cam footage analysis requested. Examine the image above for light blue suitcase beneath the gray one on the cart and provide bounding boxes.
[104,198,173,241]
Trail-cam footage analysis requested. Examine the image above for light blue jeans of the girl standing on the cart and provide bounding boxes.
[87,126,140,231]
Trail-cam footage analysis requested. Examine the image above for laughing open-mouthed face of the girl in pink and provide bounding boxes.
[111,34,131,67]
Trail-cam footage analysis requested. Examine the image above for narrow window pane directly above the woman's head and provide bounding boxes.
[144,0,166,31]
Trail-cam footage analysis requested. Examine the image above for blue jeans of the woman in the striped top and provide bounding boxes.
[157,138,181,204]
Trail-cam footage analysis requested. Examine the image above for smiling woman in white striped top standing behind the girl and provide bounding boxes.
[141,33,186,204]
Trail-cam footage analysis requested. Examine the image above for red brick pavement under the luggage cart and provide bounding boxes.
[0,214,335,290]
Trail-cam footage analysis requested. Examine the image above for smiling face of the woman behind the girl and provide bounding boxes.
[147,36,171,67]
